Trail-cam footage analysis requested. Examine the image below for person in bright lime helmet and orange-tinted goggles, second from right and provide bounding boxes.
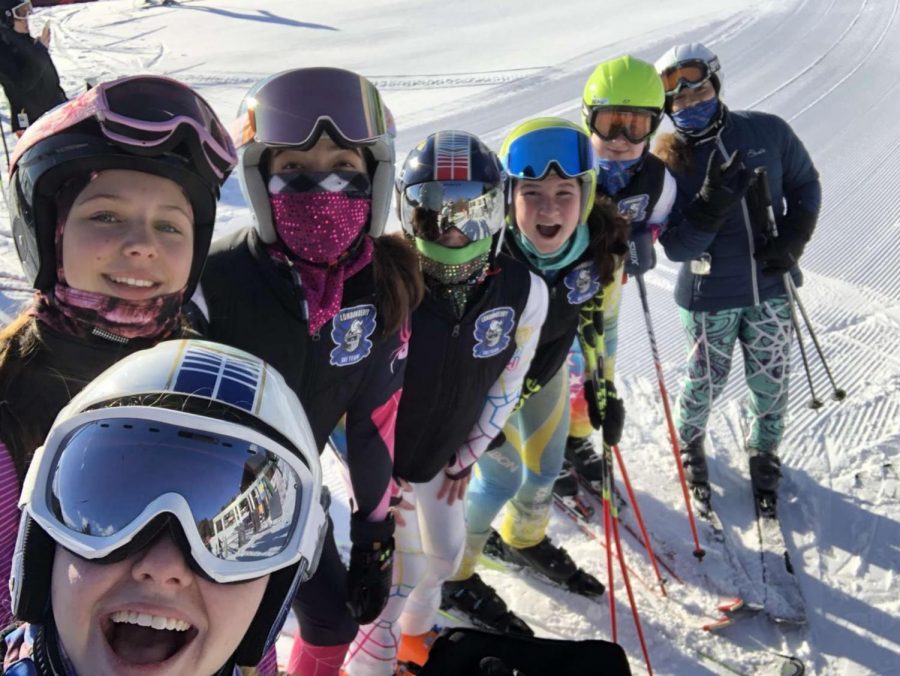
[556,56,675,495]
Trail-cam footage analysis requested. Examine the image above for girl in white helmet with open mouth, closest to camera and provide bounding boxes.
[3,340,327,676]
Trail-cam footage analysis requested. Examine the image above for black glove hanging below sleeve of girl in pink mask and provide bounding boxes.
[347,514,394,624]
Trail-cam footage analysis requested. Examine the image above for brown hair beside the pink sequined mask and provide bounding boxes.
[372,234,425,335]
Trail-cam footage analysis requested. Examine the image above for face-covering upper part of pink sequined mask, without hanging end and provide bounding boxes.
[269,171,372,265]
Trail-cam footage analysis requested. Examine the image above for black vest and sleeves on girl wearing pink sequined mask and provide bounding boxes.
[195,228,409,521]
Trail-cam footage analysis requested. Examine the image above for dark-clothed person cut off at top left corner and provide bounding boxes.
[0,0,66,136]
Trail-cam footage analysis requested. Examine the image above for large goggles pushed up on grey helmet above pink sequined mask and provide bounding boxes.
[232,68,396,147]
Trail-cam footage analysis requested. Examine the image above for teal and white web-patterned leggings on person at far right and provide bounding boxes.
[676,296,792,453]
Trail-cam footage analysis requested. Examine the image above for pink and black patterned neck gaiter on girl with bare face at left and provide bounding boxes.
[31,219,184,343]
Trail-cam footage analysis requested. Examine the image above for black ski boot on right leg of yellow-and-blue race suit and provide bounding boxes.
[484,531,606,597]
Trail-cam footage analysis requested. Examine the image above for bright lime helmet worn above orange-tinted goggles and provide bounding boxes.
[581,54,666,132]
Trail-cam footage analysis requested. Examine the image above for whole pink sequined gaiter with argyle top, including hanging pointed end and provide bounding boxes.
[268,171,374,335]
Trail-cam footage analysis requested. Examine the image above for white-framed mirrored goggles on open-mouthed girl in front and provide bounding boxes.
[20,407,325,582]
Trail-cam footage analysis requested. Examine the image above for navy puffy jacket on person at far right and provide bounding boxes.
[660,110,822,311]
